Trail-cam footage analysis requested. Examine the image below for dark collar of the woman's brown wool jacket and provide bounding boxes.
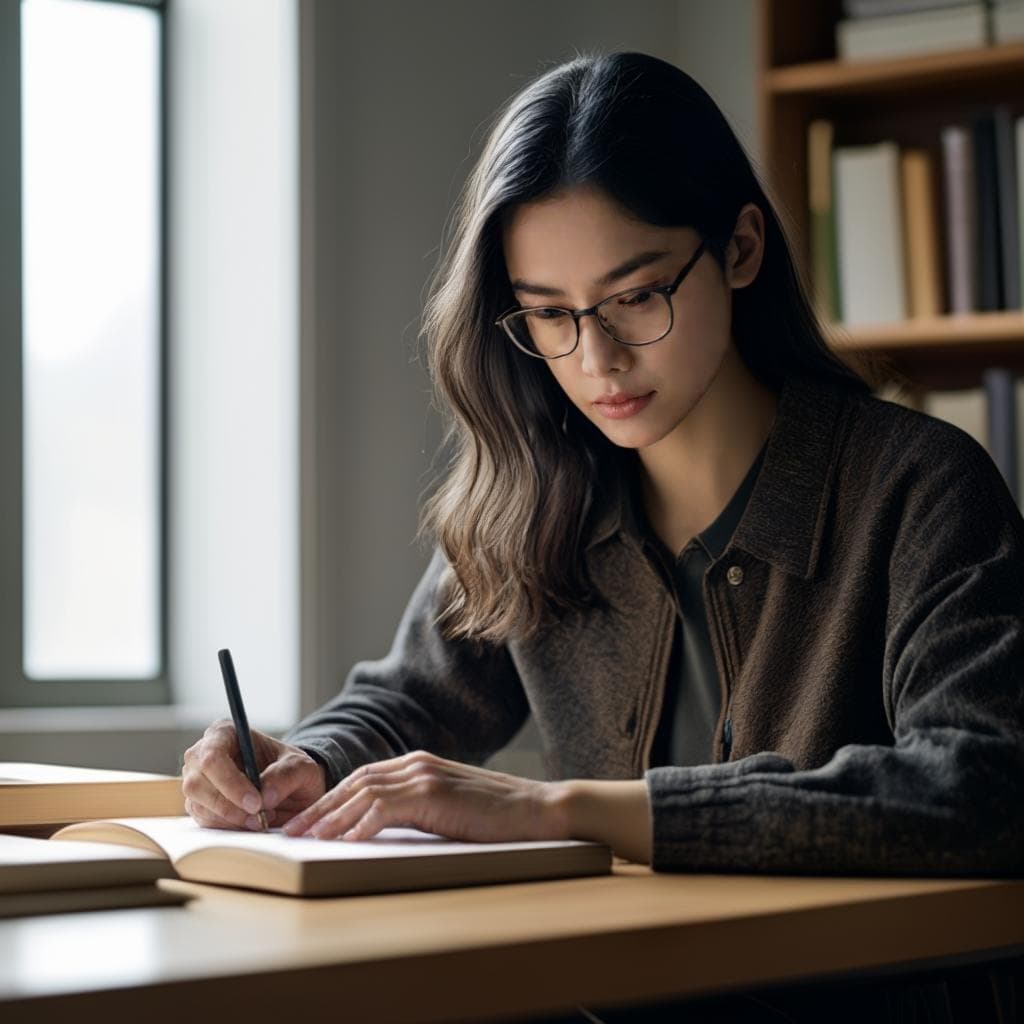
[587,373,848,580]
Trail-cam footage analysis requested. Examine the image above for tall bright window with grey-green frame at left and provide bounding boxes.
[0,0,168,707]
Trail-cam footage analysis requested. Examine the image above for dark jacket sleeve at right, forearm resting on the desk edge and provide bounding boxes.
[645,432,1024,876]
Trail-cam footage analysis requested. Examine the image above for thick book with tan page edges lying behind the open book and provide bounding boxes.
[0,762,184,829]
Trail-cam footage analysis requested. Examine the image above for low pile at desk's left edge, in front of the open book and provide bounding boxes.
[0,835,184,918]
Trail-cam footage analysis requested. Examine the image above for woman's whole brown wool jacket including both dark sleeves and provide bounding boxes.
[286,376,1024,874]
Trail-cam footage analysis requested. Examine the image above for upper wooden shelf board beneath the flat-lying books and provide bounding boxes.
[763,42,1024,97]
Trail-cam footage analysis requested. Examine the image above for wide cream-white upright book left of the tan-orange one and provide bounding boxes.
[835,142,906,326]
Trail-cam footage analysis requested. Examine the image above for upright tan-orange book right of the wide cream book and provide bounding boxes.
[900,150,945,316]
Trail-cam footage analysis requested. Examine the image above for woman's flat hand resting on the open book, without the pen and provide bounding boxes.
[284,751,568,843]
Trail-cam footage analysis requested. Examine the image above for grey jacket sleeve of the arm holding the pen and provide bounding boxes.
[284,549,528,787]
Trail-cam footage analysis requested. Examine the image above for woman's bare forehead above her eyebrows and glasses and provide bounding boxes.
[502,186,695,289]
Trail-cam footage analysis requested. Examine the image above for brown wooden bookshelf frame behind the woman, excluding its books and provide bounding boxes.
[755,0,1024,393]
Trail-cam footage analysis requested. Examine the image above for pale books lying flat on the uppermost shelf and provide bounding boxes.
[836,0,991,60]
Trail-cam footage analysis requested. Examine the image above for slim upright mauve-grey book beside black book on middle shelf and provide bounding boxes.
[942,125,978,313]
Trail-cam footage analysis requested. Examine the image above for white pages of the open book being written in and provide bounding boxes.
[54,817,594,862]
